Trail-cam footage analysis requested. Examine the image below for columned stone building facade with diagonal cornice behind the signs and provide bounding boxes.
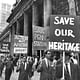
[0,0,80,56]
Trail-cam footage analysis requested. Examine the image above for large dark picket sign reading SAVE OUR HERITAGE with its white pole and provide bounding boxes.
[49,15,80,80]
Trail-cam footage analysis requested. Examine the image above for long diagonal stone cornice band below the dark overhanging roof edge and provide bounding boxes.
[0,0,34,41]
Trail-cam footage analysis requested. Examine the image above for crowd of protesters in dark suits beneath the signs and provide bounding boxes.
[0,50,80,80]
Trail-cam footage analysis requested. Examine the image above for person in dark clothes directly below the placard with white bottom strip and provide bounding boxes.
[16,57,29,80]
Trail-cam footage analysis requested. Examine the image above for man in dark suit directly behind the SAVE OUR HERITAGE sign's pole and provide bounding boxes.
[56,53,80,80]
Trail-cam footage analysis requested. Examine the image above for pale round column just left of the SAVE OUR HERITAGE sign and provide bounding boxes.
[43,0,52,27]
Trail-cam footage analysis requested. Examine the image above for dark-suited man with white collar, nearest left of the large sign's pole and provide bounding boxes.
[37,50,52,80]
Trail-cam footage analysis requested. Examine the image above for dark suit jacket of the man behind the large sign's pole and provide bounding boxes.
[56,63,80,80]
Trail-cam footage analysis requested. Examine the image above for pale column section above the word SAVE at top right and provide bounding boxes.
[68,0,76,16]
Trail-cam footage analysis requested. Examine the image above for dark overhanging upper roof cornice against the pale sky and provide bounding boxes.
[7,0,33,23]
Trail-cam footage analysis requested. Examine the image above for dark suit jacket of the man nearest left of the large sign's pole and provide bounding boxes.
[37,60,53,80]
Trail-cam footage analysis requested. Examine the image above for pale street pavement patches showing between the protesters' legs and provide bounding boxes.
[0,67,40,80]
